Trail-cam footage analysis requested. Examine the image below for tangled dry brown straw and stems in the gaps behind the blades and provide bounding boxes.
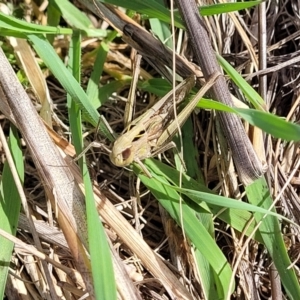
[2,0,300,299]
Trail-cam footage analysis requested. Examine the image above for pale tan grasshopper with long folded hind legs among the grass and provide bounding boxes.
[110,72,220,177]
